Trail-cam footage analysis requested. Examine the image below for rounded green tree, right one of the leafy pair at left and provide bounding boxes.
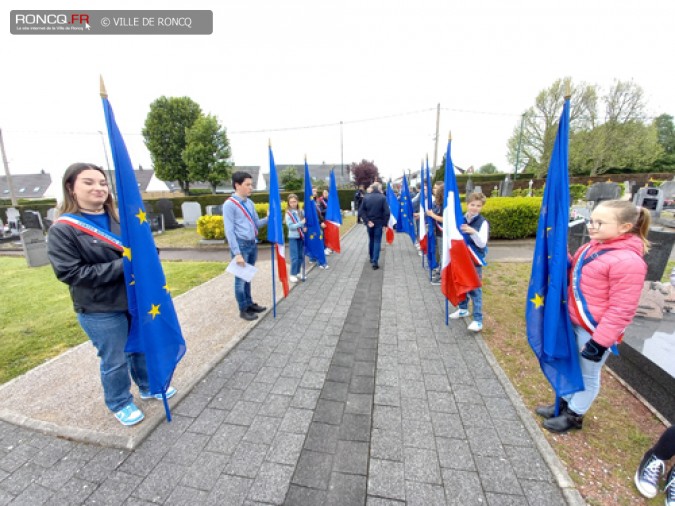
[183,114,234,195]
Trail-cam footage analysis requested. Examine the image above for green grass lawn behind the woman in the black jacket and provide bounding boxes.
[0,257,227,384]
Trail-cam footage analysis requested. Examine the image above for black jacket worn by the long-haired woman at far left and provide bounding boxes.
[47,212,128,313]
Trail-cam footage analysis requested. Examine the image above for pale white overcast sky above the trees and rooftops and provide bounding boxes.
[0,0,675,192]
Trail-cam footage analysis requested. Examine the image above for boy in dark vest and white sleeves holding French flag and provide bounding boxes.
[450,193,490,332]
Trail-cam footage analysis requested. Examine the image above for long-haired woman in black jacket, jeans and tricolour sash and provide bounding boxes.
[47,163,176,425]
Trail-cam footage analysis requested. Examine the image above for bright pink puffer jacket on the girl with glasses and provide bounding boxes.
[568,234,647,347]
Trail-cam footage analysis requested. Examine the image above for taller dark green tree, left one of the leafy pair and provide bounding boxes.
[143,97,202,194]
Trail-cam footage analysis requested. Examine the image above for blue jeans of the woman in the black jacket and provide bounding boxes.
[77,312,150,413]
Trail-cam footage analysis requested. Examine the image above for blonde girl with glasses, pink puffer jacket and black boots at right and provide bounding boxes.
[536,200,651,433]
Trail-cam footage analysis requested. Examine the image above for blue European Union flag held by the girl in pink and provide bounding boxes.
[525,98,584,397]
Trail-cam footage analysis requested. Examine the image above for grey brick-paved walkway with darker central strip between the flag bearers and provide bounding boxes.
[0,227,583,506]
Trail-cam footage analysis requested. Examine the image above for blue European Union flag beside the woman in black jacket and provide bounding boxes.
[101,87,185,421]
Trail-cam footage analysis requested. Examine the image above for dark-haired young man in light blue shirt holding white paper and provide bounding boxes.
[223,171,267,321]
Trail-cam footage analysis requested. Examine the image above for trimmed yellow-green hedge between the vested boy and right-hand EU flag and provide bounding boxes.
[482,197,541,239]
